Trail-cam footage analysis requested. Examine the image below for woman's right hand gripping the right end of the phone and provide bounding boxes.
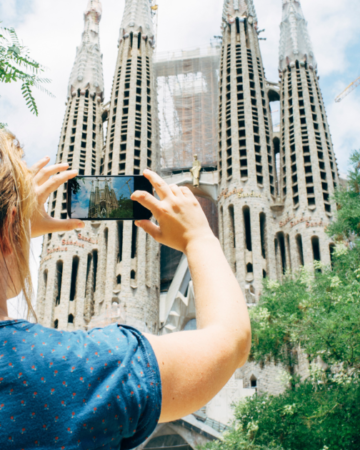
[131,169,216,253]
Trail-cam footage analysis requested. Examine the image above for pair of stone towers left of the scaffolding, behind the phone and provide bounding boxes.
[37,0,160,333]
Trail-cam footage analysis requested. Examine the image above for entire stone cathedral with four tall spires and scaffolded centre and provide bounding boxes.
[37,0,339,450]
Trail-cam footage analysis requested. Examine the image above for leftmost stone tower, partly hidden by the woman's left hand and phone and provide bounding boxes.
[36,0,104,330]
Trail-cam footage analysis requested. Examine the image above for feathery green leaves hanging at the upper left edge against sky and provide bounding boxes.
[0,27,52,128]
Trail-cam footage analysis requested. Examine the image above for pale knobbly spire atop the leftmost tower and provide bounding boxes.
[68,0,104,97]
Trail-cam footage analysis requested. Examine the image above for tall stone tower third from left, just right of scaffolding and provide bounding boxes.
[218,0,277,302]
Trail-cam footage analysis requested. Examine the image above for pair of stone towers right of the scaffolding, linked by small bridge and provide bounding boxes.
[218,0,338,303]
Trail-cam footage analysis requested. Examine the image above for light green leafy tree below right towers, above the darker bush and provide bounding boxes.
[250,248,360,382]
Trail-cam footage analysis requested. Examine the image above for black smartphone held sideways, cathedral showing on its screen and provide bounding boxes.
[67,175,153,220]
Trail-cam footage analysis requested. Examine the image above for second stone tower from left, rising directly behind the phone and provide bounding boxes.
[100,0,160,333]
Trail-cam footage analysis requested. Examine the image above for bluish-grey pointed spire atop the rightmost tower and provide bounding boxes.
[279,0,316,70]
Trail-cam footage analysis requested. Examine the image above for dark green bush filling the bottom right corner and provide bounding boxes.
[206,380,360,450]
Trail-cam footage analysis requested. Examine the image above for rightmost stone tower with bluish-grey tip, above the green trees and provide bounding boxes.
[275,0,338,278]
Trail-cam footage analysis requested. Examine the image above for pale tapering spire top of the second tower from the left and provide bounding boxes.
[120,0,154,38]
